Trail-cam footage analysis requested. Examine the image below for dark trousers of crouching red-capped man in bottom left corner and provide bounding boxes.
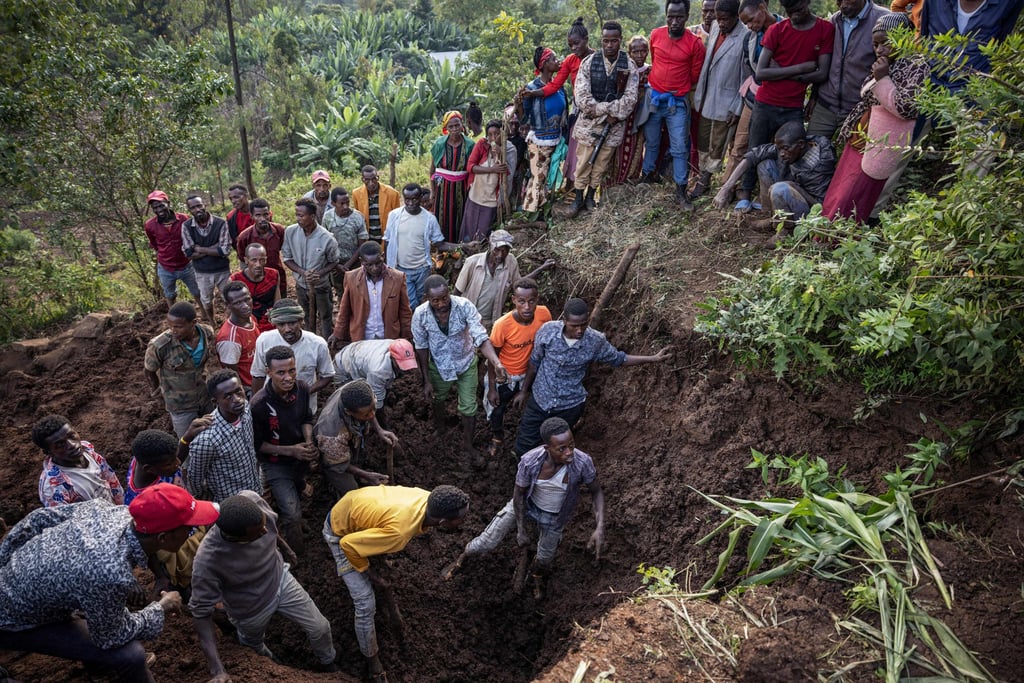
[0,618,154,683]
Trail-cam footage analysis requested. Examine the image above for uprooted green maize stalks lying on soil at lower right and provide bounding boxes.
[698,448,991,683]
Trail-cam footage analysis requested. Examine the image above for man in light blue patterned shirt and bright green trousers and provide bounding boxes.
[413,275,508,467]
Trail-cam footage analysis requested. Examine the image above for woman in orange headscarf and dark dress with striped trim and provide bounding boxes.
[430,112,473,242]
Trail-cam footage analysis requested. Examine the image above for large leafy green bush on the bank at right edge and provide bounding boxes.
[696,34,1024,395]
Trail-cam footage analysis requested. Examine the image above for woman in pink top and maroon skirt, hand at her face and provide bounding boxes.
[821,13,929,223]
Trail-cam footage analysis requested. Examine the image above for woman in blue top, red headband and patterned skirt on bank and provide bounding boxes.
[516,47,569,219]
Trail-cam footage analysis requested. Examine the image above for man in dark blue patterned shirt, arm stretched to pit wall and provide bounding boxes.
[512,299,672,457]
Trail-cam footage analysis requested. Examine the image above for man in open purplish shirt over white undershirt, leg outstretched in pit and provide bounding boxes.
[441,418,604,599]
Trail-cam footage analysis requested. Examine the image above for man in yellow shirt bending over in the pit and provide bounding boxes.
[324,485,469,681]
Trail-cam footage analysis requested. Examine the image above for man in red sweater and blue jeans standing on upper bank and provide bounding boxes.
[643,0,705,211]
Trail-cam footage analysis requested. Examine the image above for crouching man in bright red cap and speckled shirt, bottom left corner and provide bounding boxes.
[0,483,218,682]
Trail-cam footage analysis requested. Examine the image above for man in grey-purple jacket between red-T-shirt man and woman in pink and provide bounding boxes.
[805,0,890,138]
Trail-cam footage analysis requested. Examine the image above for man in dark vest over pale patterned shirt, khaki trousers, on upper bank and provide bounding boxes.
[568,22,640,218]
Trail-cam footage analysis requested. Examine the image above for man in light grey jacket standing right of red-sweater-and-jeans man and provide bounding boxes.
[690,0,751,201]
